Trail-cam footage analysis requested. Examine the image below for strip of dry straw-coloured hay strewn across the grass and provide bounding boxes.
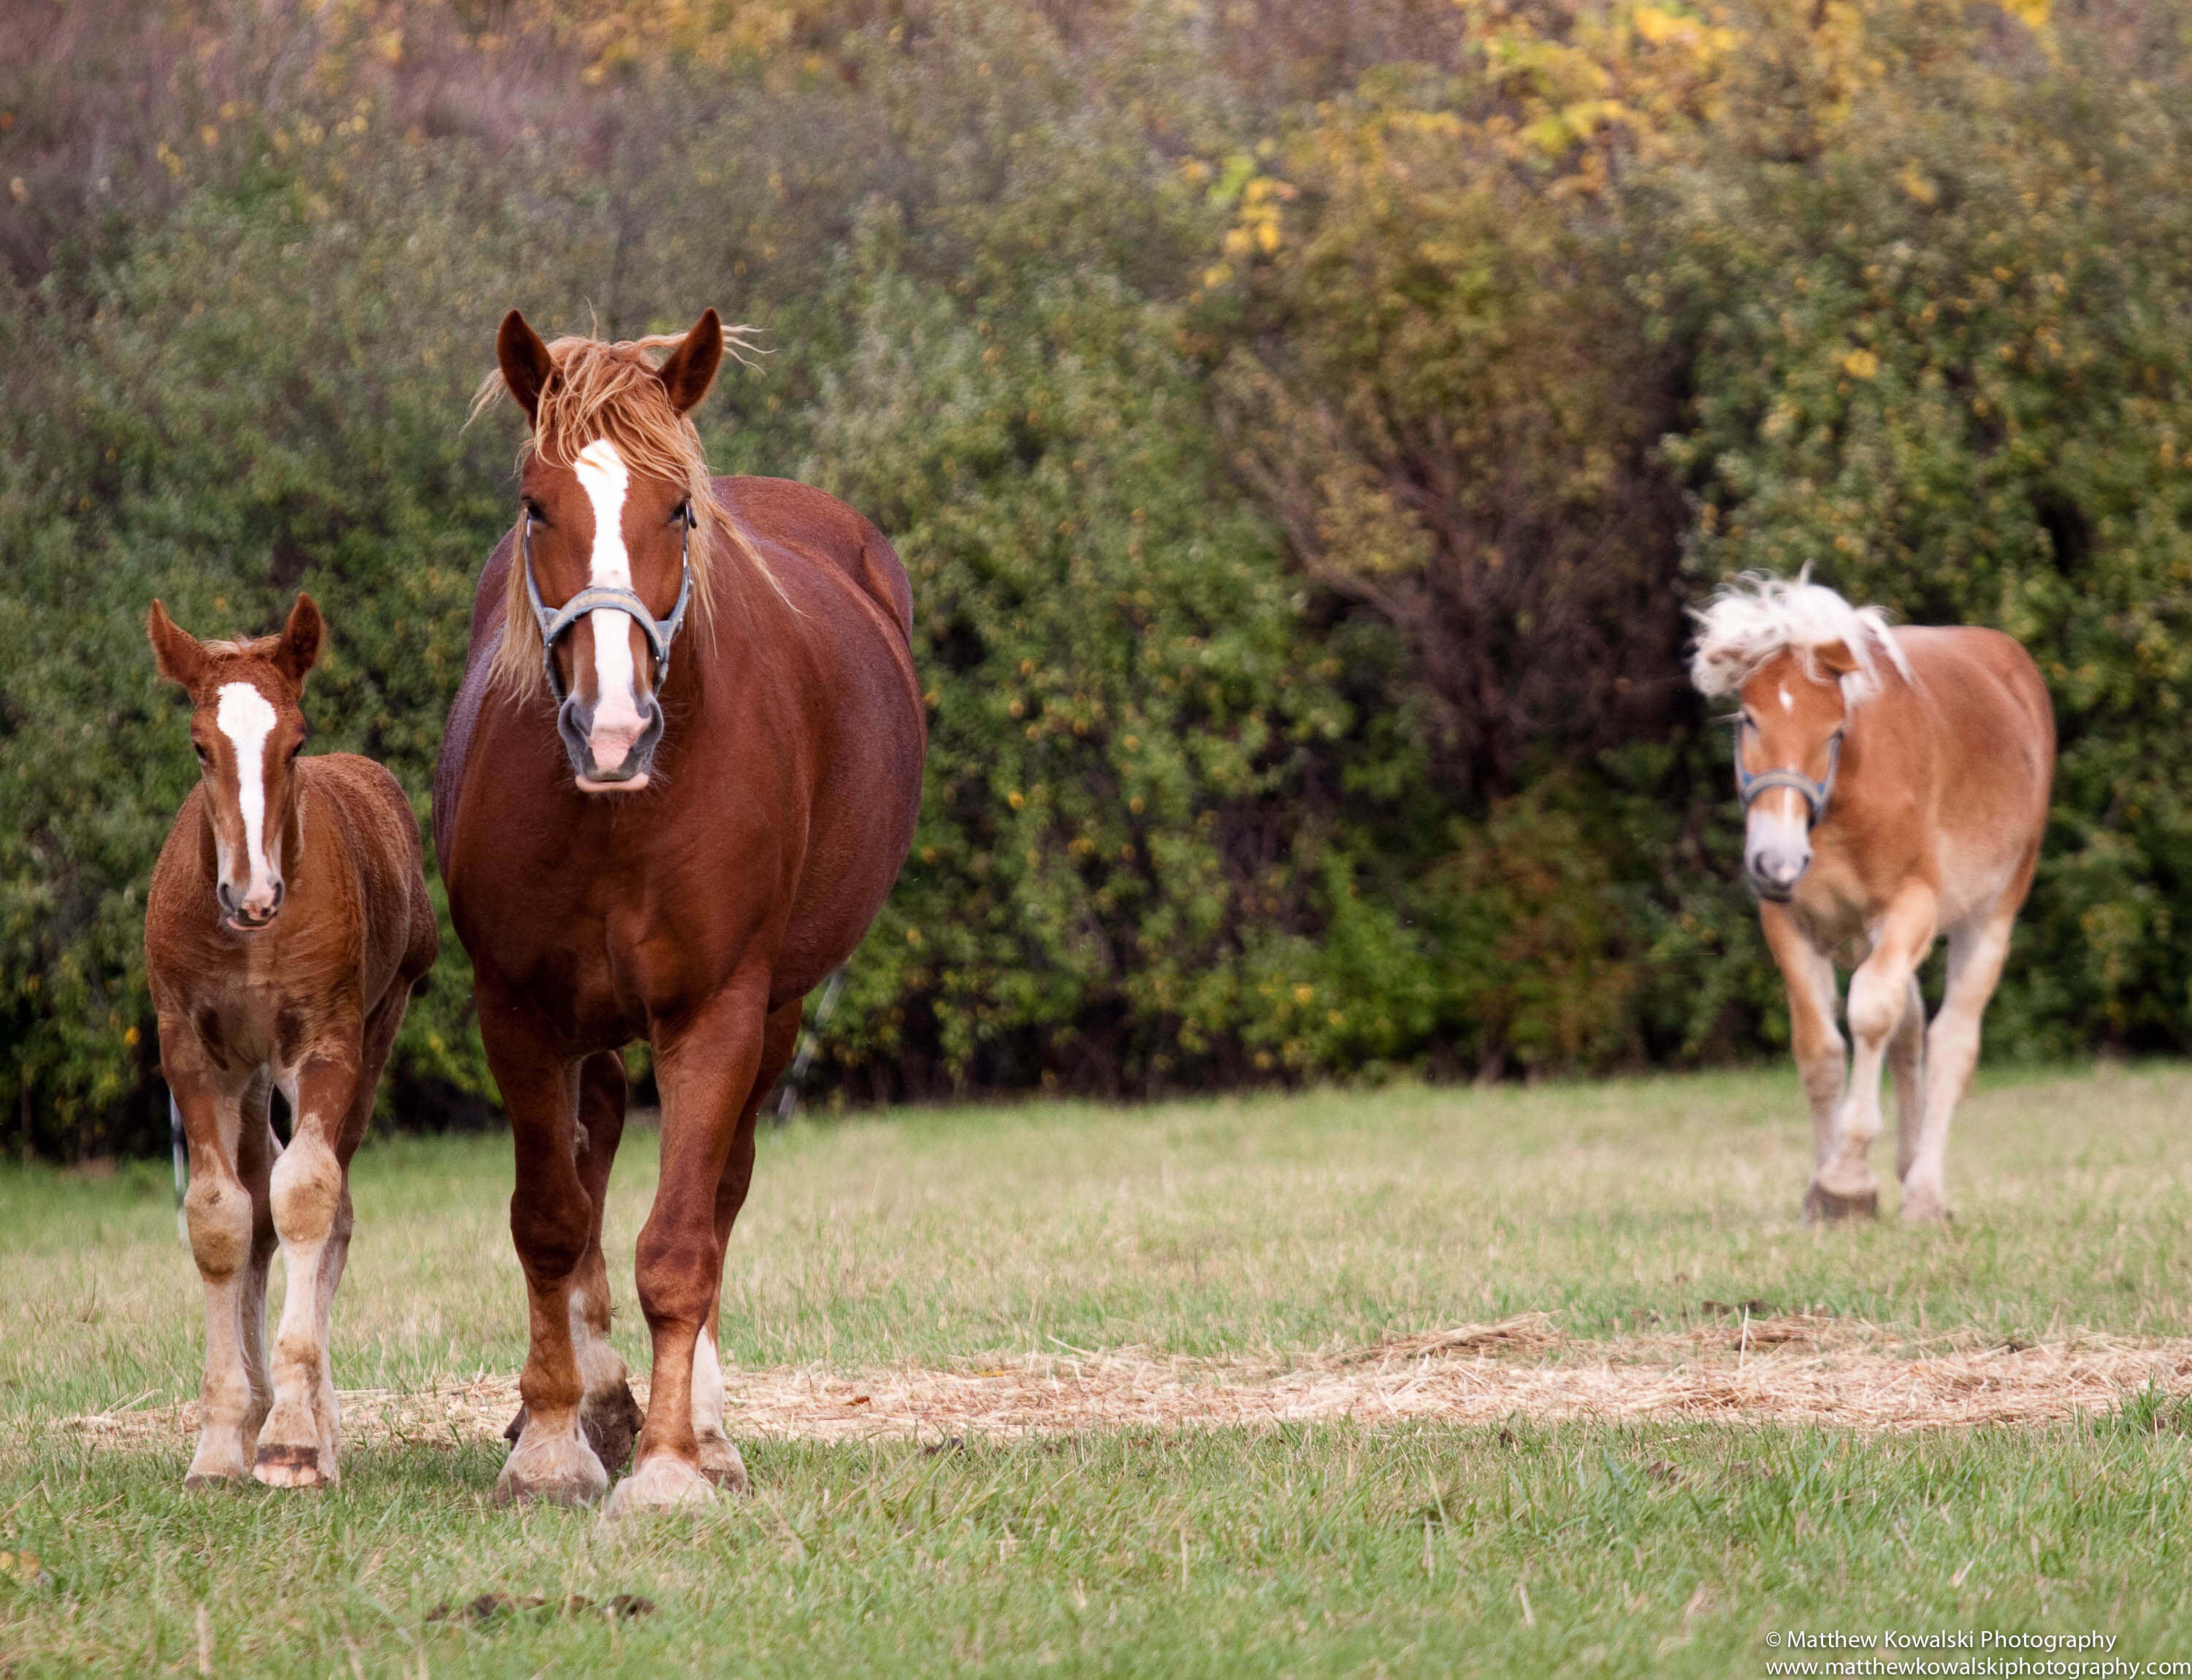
[59,1314,2192,1448]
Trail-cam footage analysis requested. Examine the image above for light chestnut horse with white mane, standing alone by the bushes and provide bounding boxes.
[1690,575,2054,1221]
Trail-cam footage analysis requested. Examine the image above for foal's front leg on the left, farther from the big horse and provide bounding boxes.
[173,1061,265,1487]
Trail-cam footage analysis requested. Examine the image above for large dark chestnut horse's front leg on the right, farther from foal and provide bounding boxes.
[609,974,767,1516]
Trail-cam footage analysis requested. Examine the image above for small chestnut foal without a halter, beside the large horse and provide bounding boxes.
[145,595,440,1487]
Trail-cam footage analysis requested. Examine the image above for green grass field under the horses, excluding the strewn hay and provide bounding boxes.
[0,1068,2192,1678]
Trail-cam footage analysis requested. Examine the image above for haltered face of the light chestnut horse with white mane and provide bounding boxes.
[1736,643,1859,904]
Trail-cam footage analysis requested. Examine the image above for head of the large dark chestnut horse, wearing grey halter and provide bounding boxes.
[495,309,723,794]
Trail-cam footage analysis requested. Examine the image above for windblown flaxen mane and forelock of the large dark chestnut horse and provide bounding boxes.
[467,327,782,693]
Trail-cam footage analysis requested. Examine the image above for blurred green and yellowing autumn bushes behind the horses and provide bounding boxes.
[0,0,2192,1153]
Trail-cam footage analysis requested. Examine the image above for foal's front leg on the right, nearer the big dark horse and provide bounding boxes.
[252,1035,366,1487]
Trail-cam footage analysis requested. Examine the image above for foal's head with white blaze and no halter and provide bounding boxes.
[147,595,320,932]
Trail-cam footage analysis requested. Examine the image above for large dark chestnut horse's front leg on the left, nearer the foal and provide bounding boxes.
[480,1000,609,1505]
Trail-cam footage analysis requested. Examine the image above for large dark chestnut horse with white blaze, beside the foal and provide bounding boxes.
[434,309,927,1511]
